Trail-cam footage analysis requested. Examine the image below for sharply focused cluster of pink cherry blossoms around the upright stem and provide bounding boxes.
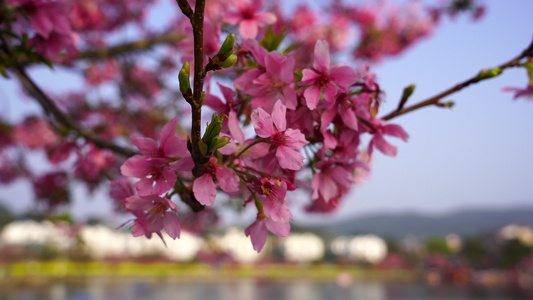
[112,39,407,251]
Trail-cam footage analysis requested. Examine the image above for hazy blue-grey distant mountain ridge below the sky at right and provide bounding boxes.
[309,207,533,238]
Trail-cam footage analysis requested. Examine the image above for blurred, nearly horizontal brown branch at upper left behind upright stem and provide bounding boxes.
[76,32,186,60]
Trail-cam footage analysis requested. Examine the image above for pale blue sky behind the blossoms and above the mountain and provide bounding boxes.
[0,0,533,225]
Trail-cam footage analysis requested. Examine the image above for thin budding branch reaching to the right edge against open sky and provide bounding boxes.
[381,38,533,120]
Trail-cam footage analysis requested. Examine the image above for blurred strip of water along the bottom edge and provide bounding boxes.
[0,278,516,300]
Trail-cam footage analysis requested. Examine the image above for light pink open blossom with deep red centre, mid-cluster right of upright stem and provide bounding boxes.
[252,100,308,170]
